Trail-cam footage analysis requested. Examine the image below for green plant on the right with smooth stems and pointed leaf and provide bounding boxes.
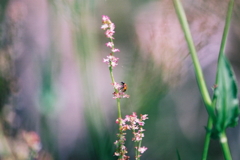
[173,0,240,160]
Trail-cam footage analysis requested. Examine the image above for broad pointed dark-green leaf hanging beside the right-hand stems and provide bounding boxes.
[214,54,240,133]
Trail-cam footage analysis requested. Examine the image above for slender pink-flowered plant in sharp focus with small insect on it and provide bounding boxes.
[101,15,148,160]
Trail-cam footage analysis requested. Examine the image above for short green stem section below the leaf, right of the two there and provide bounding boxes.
[219,131,232,160]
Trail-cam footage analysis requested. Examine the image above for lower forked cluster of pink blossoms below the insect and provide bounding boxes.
[114,112,148,159]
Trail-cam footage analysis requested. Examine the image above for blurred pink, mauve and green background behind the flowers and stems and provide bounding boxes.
[0,0,240,160]
